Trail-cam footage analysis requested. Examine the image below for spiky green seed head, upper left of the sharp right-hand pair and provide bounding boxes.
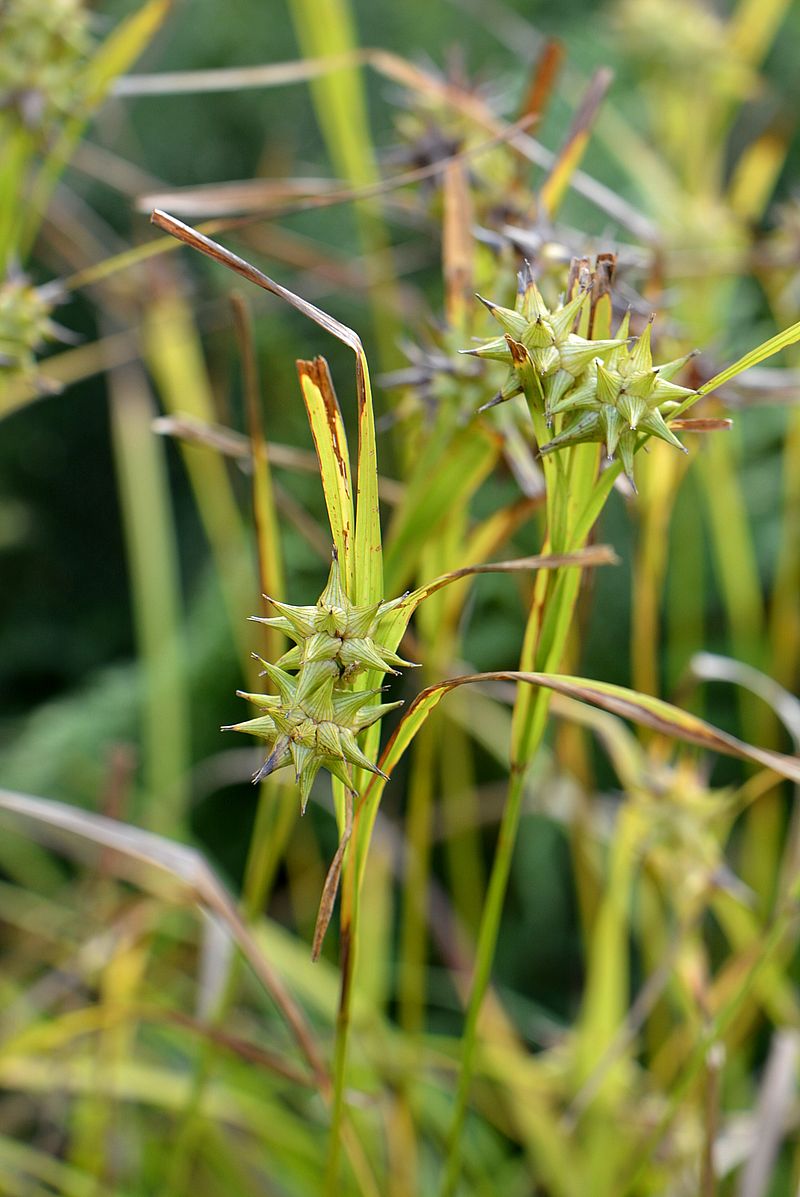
[462,262,624,417]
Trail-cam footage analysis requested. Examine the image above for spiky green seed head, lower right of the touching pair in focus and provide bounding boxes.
[539,315,695,484]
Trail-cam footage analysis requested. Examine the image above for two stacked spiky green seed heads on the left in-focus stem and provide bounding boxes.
[223,551,411,810]
